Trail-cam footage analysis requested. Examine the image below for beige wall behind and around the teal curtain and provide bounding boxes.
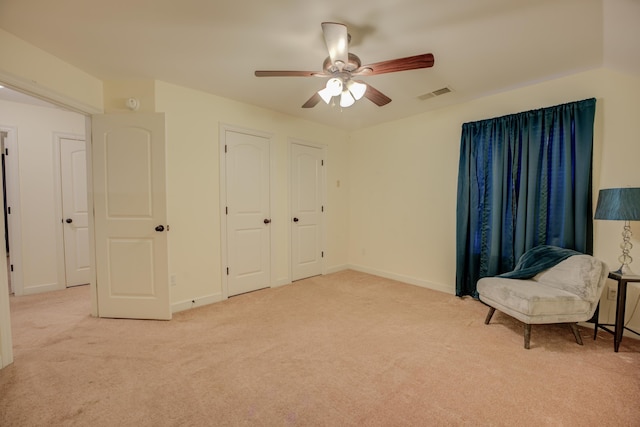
[349,69,640,332]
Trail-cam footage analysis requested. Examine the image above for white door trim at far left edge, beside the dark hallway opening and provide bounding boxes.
[0,126,24,296]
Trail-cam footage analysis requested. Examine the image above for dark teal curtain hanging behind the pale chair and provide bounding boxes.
[456,99,596,298]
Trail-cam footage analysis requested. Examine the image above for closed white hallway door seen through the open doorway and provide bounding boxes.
[60,138,91,287]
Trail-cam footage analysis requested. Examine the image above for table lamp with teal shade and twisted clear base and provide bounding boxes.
[594,188,640,275]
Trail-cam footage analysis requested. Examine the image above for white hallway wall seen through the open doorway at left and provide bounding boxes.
[0,101,85,294]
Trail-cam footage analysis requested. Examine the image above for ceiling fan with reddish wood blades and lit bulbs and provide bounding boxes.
[255,22,434,108]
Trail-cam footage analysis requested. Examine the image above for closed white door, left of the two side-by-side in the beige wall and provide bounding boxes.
[225,130,271,296]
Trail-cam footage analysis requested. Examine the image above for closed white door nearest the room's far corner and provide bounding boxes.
[291,143,323,280]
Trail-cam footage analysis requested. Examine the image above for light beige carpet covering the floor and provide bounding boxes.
[0,271,640,426]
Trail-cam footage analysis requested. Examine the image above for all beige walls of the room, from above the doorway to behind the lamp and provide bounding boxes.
[0,24,640,358]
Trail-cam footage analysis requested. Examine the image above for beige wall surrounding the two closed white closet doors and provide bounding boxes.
[156,82,348,310]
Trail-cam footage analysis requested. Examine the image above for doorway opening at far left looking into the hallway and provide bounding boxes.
[0,92,90,296]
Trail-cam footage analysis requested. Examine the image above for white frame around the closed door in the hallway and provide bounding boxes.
[53,132,86,289]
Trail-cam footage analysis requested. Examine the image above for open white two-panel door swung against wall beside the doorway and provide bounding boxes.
[92,113,171,319]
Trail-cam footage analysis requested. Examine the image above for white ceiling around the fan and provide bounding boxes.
[0,0,640,130]
